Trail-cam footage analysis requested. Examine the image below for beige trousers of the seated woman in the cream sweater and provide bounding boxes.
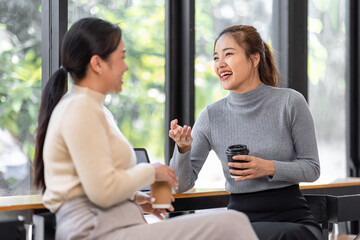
[55,197,258,240]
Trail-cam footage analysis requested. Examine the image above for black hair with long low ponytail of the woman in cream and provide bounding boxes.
[34,18,121,191]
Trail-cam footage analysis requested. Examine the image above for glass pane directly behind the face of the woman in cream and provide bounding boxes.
[69,0,165,162]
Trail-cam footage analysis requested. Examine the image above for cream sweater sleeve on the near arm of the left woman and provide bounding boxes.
[61,101,155,207]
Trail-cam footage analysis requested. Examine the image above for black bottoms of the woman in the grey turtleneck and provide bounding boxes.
[228,185,322,240]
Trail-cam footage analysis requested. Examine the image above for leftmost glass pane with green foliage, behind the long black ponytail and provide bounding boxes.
[0,0,41,196]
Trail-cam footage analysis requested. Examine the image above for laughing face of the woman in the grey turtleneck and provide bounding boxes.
[214,34,260,93]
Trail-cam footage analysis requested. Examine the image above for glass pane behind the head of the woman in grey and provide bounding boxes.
[195,0,273,187]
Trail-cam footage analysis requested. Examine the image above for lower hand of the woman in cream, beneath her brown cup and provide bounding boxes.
[135,192,175,220]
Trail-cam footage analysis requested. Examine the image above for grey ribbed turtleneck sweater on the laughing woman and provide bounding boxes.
[170,84,320,193]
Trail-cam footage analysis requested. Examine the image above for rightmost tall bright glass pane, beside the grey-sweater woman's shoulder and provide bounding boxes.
[308,0,346,179]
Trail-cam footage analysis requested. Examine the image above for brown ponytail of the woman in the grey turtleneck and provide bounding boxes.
[259,42,281,87]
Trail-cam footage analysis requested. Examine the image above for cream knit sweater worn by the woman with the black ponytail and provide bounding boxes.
[43,85,155,212]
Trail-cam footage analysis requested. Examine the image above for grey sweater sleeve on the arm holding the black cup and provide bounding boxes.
[270,91,320,182]
